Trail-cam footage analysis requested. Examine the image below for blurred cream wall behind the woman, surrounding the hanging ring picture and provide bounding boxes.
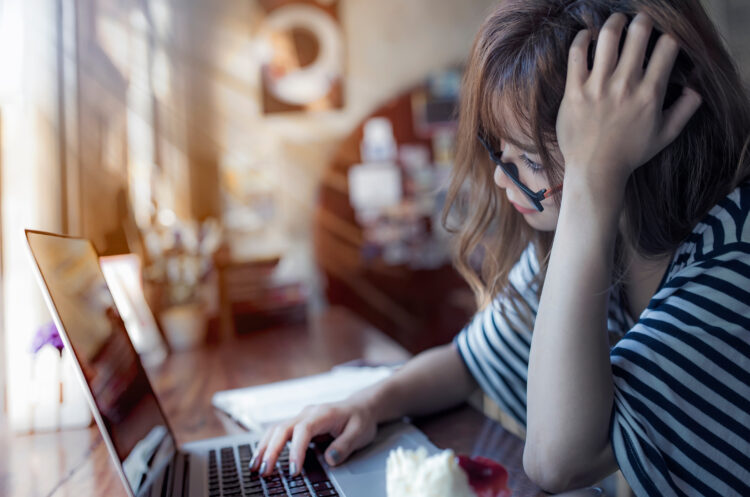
[0,0,750,414]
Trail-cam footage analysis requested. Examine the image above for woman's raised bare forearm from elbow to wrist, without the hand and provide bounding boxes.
[524,178,621,491]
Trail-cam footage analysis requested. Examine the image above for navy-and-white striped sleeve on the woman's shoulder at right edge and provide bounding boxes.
[610,187,750,497]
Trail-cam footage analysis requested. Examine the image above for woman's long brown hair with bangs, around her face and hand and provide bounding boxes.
[443,0,750,308]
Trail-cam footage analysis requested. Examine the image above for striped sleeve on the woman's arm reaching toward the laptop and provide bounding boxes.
[454,242,539,426]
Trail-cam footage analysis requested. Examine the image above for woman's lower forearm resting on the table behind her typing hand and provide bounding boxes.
[357,344,478,422]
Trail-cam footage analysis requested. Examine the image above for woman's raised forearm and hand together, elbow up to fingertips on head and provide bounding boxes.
[524,13,701,491]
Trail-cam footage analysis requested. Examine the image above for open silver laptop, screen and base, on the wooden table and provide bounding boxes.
[26,230,437,497]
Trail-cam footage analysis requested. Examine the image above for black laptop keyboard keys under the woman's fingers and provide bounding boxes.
[208,444,339,497]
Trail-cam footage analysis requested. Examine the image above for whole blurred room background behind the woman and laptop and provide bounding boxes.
[0,0,750,431]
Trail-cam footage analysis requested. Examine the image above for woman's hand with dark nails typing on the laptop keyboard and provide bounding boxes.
[250,399,377,475]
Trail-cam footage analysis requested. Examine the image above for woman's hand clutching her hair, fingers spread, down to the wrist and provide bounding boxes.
[557,13,701,189]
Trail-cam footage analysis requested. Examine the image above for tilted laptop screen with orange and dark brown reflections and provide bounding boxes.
[26,231,175,495]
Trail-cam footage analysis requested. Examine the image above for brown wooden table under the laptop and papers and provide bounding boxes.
[0,308,576,497]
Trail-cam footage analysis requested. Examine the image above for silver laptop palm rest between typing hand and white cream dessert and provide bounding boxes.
[329,422,440,496]
